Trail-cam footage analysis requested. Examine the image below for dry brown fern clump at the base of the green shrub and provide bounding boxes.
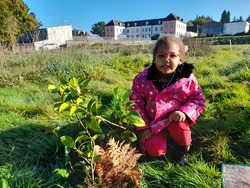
[94,139,142,188]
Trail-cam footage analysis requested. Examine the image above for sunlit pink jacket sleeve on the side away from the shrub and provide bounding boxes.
[177,75,206,125]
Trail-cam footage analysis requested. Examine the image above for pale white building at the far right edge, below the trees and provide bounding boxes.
[223,22,249,35]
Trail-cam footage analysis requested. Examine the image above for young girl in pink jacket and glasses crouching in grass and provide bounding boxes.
[130,36,205,166]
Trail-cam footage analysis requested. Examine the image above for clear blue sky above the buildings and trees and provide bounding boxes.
[23,0,250,32]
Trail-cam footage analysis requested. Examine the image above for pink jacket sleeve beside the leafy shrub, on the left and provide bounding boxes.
[129,76,150,130]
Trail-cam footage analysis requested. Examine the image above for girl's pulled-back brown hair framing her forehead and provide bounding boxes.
[152,35,186,61]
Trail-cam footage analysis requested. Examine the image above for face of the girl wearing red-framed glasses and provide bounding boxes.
[154,42,183,75]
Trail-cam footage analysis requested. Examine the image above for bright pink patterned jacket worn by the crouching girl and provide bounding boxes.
[129,64,206,133]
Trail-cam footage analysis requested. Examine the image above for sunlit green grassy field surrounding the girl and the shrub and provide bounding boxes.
[0,41,250,188]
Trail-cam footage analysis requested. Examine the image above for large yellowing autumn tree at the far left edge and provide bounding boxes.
[0,0,41,44]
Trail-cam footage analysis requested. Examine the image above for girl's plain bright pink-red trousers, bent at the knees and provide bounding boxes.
[140,121,192,156]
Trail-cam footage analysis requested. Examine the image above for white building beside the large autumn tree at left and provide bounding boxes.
[34,25,73,50]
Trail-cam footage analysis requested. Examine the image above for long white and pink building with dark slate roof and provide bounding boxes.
[105,13,186,40]
